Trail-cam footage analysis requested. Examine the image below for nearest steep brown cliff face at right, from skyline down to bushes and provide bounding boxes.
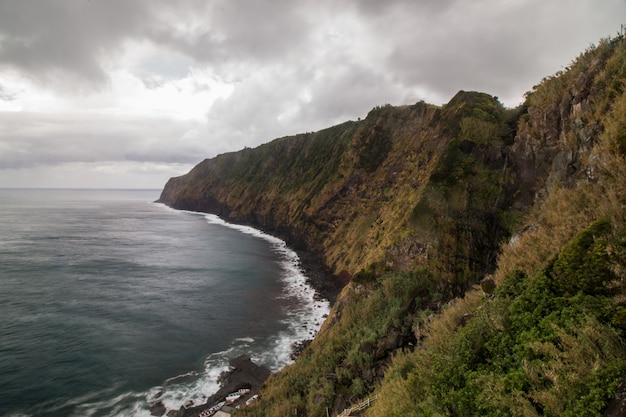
[511,39,619,205]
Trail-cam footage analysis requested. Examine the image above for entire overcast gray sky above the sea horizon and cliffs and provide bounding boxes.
[0,0,626,189]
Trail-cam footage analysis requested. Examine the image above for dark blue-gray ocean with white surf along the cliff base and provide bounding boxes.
[0,189,330,417]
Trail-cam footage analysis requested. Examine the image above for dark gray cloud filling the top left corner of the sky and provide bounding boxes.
[0,0,150,89]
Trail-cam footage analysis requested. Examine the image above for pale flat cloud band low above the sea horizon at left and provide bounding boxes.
[0,113,201,170]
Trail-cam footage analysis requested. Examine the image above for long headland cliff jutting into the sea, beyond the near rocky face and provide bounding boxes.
[160,92,513,290]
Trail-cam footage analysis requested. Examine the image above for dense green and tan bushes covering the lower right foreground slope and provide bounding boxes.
[371,219,626,417]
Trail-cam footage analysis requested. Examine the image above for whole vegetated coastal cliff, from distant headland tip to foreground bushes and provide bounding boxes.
[161,37,626,416]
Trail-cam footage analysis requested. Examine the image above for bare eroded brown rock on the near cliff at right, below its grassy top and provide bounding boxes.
[509,49,606,206]
